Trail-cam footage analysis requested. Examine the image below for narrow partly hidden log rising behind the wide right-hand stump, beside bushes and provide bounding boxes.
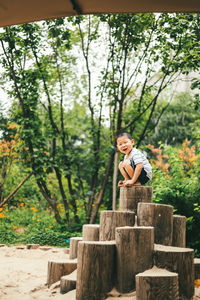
[172,216,186,248]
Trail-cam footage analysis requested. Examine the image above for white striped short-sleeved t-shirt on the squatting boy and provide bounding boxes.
[124,148,152,180]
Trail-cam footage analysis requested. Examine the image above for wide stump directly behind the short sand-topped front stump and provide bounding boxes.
[154,245,194,300]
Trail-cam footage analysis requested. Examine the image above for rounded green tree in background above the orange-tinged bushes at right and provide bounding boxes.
[144,93,200,146]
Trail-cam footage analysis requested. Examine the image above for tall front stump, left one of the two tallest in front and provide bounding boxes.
[76,241,116,300]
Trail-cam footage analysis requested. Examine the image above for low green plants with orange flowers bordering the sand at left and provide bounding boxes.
[0,206,81,247]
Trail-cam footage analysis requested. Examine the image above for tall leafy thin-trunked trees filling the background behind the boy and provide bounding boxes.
[0,14,199,237]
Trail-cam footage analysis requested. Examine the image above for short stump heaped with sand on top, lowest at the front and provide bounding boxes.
[136,266,179,300]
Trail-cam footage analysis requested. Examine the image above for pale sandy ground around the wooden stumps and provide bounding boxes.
[0,246,200,300]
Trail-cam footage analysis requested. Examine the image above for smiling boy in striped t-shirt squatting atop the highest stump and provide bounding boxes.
[116,132,152,186]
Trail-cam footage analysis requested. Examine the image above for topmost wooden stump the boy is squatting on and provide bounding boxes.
[119,185,153,214]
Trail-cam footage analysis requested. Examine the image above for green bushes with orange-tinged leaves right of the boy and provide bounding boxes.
[152,141,200,256]
